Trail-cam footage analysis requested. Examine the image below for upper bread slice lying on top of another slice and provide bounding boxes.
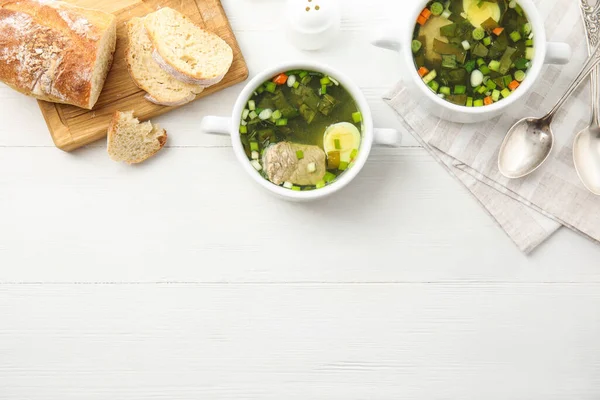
[144,7,233,86]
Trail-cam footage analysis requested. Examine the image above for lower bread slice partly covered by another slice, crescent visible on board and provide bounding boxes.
[126,18,204,106]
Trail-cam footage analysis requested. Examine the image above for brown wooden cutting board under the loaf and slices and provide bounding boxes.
[38,0,248,151]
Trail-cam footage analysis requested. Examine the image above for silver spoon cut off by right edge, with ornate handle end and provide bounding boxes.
[573,0,600,195]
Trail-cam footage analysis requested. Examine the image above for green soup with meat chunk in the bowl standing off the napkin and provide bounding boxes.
[239,70,363,191]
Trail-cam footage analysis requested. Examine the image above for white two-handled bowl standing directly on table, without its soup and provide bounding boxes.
[200,61,400,201]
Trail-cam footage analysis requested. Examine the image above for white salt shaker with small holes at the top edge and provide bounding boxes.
[286,0,341,50]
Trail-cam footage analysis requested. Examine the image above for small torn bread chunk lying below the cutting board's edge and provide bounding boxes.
[108,111,167,164]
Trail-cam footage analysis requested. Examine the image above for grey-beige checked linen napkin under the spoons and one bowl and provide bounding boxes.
[384,0,600,253]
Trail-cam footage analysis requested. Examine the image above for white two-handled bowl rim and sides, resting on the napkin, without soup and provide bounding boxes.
[372,0,571,123]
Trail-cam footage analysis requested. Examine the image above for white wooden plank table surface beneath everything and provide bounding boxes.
[0,0,600,400]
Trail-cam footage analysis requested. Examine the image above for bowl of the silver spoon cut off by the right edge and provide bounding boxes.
[573,125,600,196]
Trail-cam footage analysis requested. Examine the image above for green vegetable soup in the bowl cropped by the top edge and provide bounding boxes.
[411,0,534,107]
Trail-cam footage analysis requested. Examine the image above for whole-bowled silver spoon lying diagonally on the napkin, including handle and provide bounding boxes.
[498,43,600,179]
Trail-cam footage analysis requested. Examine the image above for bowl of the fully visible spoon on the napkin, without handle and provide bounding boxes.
[498,118,554,179]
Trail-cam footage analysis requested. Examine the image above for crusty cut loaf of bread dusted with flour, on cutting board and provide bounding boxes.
[0,0,117,109]
